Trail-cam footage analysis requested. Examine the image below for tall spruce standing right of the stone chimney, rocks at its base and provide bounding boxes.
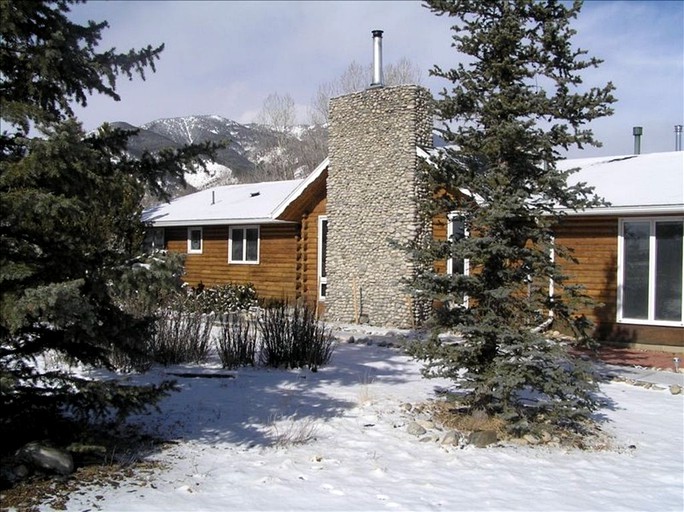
[413,0,614,432]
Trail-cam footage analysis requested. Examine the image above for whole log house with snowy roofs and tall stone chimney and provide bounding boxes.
[144,32,684,349]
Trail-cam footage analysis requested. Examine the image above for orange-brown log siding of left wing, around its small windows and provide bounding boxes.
[165,224,299,300]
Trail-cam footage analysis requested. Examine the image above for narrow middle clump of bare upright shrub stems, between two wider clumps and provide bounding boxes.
[216,313,257,368]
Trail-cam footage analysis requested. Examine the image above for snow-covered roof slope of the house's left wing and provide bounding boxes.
[143,180,305,227]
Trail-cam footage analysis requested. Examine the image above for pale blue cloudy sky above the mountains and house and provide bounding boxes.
[70,0,684,157]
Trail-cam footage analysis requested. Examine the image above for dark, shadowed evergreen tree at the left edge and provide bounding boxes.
[0,0,215,442]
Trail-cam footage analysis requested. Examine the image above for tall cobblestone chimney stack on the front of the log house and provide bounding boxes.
[326,85,433,327]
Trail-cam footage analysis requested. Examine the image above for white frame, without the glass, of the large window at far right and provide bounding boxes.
[616,217,684,327]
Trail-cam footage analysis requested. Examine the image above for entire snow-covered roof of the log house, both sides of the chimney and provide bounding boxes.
[143,148,684,227]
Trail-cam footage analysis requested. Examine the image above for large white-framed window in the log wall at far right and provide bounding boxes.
[618,217,684,325]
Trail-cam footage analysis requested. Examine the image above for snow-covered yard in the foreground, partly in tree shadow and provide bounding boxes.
[60,331,684,512]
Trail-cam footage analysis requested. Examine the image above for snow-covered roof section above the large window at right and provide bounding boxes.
[557,151,684,215]
